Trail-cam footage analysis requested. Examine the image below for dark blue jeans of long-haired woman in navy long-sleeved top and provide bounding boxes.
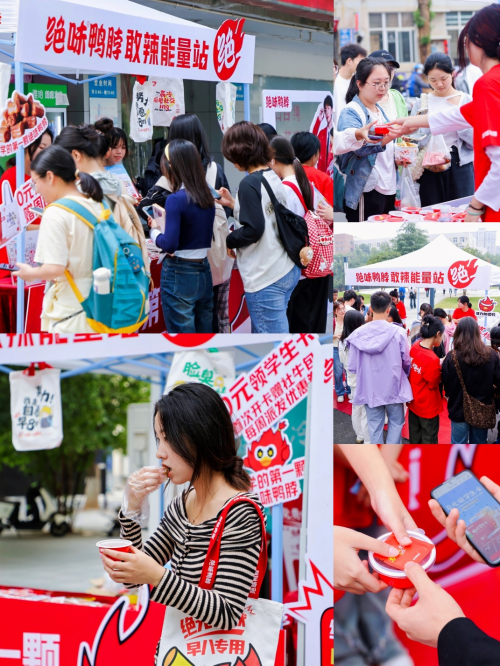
[160,257,213,333]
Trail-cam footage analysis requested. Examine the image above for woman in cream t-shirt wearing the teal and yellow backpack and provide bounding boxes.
[13,145,104,333]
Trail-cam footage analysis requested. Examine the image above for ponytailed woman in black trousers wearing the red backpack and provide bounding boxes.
[270,136,333,333]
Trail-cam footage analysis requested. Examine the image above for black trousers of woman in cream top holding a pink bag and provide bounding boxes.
[418,146,474,208]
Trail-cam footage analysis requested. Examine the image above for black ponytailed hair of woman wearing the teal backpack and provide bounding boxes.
[31,145,104,203]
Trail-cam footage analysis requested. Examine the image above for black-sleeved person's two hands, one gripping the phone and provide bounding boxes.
[386,476,500,666]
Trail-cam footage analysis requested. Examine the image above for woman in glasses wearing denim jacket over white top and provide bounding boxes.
[338,57,399,222]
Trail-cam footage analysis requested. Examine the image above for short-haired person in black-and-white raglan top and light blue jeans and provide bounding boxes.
[219,120,304,333]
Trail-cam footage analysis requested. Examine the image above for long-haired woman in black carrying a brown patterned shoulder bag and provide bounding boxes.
[443,317,500,444]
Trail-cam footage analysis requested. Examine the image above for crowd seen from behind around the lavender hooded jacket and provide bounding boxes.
[333,289,500,444]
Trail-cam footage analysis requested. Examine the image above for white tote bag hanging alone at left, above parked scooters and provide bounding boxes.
[9,363,63,451]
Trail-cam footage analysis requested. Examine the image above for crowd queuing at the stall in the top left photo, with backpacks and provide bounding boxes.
[0,113,333,333]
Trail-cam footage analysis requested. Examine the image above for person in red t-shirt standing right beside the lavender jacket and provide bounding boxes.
[408,315,444,444]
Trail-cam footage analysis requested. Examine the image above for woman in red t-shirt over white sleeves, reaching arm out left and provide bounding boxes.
[391,4,500,222]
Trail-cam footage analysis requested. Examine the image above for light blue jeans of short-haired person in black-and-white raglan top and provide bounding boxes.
[245,266,300,333]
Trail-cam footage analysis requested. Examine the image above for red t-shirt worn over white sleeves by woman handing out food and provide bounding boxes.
[460,65,500,222]
